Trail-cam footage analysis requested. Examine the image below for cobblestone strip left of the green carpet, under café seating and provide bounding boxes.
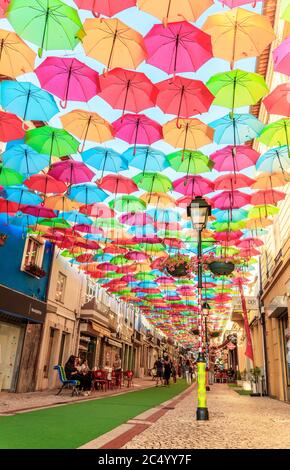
[0,377,155,415]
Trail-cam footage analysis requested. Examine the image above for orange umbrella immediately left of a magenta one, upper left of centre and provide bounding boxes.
[60,109,113,151]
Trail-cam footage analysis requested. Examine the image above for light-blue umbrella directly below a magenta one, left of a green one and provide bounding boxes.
[122,145,169,172]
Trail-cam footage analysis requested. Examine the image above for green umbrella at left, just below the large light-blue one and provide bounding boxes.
[25,126,79,165]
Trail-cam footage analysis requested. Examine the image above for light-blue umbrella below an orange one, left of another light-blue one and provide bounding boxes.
[81,147,128,176]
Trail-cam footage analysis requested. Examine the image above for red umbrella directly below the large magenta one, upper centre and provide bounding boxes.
[156,76,214,123]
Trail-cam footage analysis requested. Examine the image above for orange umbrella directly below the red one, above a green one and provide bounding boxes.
[163,118,214,150]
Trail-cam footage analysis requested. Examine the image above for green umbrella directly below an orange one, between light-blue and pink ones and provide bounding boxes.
[166,150,213,175]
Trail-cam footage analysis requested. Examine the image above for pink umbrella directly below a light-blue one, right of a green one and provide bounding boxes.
[210,145,260,172]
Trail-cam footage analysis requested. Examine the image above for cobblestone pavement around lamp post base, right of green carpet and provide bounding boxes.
[123,384,290,449]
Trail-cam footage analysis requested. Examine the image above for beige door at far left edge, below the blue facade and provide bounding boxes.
[0,322,23,391]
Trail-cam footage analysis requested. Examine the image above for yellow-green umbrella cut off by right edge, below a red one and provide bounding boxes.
[258,118,290,157]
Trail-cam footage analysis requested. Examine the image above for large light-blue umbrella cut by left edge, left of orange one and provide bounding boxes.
[1,80,59,121]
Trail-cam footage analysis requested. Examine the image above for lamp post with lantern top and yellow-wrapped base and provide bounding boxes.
[187,196,211,421]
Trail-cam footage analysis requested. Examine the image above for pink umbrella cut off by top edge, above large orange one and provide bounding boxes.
[75,0,136,18]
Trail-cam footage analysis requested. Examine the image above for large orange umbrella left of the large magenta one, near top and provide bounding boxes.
[78,18,147,69]
